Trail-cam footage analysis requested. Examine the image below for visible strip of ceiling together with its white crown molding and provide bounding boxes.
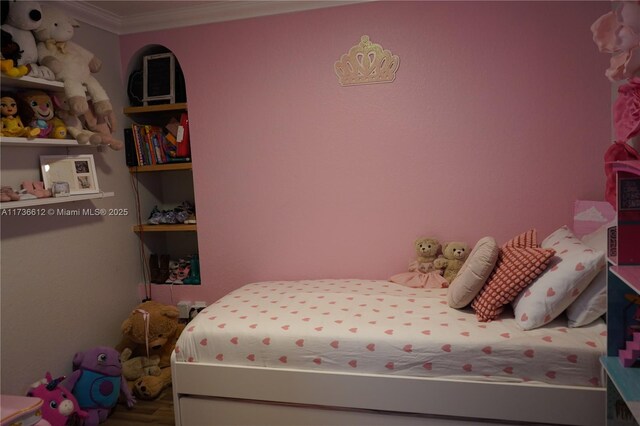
[57,0,364,34]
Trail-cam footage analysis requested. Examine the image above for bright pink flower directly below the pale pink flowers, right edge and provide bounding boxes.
[613,77,640,142]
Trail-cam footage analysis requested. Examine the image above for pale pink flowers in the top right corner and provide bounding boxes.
[591,0,640,81]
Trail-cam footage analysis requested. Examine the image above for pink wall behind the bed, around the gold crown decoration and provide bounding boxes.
[121,2,610,301]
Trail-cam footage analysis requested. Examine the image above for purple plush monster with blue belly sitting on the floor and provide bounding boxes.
[64,346,136,426]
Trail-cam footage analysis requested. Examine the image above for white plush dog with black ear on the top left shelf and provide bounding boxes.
[2,0,55,80]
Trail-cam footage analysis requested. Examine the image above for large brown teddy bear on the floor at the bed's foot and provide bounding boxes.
[116,301,184,399]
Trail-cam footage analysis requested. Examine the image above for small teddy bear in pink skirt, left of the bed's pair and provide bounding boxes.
[389,237,446,288]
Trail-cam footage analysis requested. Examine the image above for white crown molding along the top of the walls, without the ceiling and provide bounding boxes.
[57,0,373,35]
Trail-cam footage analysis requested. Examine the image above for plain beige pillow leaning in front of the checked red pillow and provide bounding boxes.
[447,237,500,309]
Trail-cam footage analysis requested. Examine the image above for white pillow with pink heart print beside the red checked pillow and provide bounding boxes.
[513,226,604,330]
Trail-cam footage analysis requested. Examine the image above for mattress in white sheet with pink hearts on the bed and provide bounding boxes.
[175,279,606,387]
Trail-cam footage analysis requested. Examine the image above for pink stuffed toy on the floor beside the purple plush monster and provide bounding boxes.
[27,371,88,426]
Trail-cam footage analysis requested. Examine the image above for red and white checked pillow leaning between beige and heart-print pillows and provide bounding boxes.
[471,229,555,321]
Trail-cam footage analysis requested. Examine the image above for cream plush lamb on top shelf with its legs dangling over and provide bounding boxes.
[33,3,115,128]
